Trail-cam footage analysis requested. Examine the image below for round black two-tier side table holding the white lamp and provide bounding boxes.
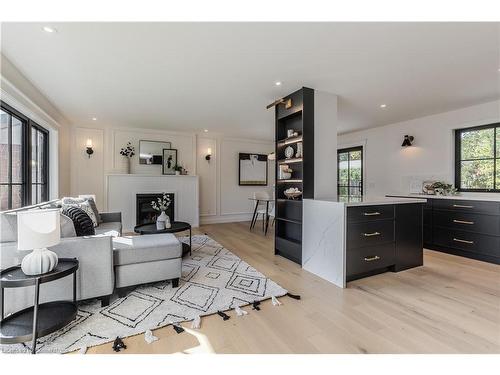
[0,258,78,354]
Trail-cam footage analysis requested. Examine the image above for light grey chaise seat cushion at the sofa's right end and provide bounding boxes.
[113,233,182,266]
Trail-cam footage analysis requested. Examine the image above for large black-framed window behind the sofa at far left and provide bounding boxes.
[0,102,49,211]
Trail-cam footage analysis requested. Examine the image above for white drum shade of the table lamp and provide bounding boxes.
[17,209,61,250]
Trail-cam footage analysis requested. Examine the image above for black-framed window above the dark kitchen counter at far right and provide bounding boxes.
[455,123,500,192]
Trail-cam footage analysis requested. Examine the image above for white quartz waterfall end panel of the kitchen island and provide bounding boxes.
[302,199,345,288]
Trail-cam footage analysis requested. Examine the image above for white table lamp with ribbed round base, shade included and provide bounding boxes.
[17,209,61,275]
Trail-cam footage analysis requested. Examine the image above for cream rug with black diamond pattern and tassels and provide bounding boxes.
[0,235,287,353]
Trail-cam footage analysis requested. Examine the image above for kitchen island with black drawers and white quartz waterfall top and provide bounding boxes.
[302,197,426,288]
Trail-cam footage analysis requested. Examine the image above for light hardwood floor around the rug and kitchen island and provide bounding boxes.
[87,223,500,354]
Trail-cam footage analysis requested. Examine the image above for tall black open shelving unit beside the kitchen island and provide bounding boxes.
[274,87,314,264]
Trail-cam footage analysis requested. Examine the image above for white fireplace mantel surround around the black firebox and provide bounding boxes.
[106,174,200,232]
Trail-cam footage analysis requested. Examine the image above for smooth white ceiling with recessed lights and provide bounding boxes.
[1,23,500,139]
